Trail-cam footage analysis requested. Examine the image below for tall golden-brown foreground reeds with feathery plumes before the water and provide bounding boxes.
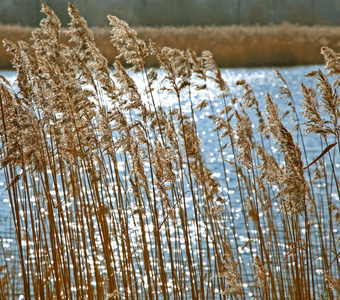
[0,3,340,299]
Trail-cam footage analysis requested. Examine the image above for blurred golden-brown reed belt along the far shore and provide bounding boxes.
[0,24,340,69]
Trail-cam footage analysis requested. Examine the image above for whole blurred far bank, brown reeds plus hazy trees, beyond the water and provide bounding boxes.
[0,0,340,69]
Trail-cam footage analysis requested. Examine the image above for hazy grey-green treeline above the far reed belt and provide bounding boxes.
[0,0,340,26]
